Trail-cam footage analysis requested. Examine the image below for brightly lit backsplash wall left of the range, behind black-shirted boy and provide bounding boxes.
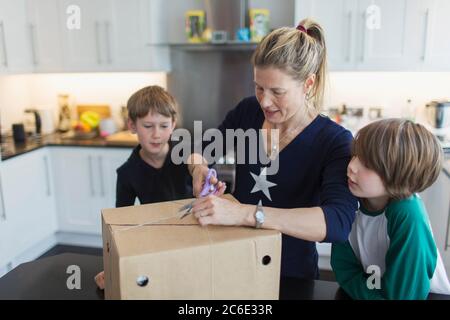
[0,72,167,132]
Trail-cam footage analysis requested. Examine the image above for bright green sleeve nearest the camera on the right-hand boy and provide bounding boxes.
[382,200,437,300]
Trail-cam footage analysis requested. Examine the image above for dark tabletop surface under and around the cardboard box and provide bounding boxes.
[0,253,450,300]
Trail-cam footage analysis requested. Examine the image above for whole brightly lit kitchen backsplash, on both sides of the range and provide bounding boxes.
[0,72,450,132]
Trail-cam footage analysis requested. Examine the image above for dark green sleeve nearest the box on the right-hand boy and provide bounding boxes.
[331,241,383,300]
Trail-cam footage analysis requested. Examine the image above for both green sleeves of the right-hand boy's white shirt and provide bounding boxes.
[331,198,437,300]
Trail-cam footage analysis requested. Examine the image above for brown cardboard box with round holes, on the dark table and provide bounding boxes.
[102,195,281,299]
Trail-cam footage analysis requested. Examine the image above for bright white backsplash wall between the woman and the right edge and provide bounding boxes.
[324,72,450,131]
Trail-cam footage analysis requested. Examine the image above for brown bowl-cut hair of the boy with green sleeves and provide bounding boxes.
[352,119,444,199]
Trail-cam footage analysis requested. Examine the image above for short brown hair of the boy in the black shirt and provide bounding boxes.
[127,86,178,122]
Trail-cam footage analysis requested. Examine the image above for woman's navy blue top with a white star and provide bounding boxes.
[219,97,357,279]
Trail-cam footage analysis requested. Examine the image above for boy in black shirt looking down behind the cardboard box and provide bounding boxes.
[116,86,192,207]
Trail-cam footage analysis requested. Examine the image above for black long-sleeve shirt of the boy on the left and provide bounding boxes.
[116,145,193,207]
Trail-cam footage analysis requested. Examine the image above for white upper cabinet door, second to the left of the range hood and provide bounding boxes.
[60,0,112,72]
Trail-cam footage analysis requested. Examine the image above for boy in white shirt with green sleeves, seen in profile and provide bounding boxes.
[331,119,450,299]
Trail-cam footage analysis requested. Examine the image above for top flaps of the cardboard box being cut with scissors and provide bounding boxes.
[102,194,278,256]
